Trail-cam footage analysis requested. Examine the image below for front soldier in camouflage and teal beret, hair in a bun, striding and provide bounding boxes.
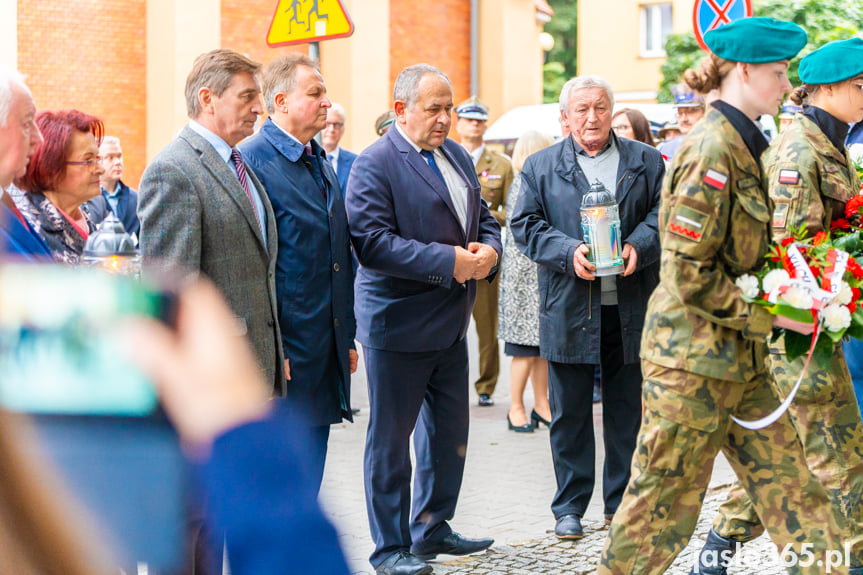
[597,18,842,575]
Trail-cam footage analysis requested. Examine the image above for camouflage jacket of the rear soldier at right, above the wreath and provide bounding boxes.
[762,114,860,241]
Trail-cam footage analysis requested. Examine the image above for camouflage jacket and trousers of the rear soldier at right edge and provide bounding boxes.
[713,114,863,557]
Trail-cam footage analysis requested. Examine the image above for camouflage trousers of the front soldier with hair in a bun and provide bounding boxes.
[597,361,843,575]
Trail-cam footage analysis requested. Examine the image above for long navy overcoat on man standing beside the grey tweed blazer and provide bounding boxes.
[240,118,356,425]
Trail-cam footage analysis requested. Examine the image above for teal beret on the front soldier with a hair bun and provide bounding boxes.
[704,18,807,64]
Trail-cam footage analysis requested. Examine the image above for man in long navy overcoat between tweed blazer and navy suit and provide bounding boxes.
[240,54,357,496]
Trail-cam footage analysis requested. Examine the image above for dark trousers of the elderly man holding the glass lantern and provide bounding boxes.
[548,306,641,519]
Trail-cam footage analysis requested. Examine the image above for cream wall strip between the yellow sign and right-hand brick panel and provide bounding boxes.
[320,0,392,153]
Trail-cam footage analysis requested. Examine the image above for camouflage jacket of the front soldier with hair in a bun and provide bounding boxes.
[641,109,773,382]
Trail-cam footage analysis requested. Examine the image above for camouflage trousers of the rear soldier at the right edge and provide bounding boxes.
[713,346,863,564]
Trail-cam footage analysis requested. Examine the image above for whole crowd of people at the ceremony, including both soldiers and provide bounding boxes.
[0,12,863,575]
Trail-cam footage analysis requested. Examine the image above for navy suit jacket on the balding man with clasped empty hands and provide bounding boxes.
[346,129,501,352]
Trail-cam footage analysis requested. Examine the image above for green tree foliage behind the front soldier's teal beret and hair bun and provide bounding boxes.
[657,0,863,102]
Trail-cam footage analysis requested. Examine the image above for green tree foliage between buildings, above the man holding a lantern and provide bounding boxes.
[542,0,578,103]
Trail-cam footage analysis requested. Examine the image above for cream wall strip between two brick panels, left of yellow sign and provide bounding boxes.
[147,0,221,159]
